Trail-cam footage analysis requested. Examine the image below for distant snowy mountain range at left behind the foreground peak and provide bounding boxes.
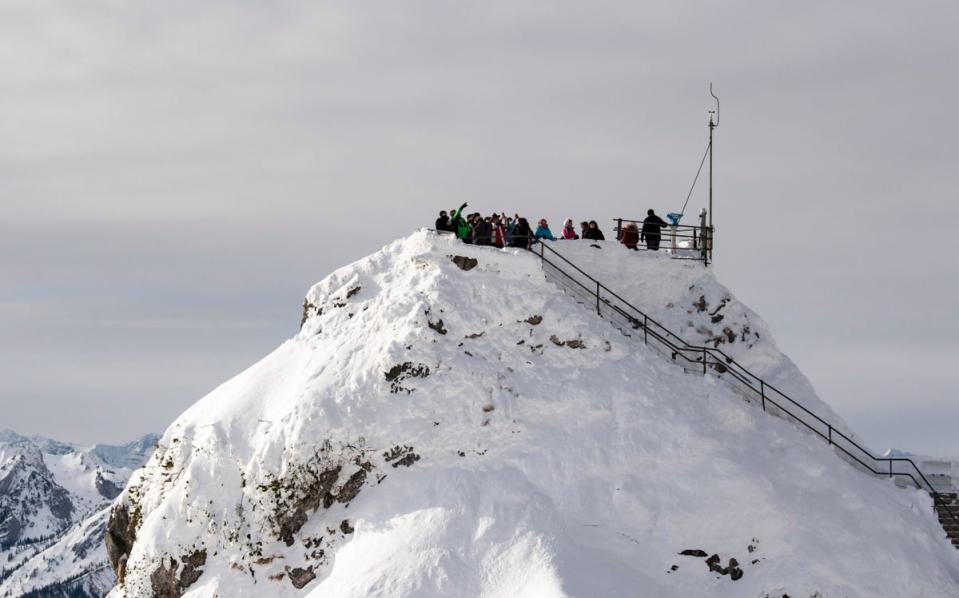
[0,430,158,598]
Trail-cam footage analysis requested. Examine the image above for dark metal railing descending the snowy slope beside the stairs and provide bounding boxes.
[530,242,959,522]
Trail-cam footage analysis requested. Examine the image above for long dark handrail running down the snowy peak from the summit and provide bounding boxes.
[529,241,959,522]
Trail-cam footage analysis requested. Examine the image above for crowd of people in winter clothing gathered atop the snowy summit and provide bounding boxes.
[436,203,666,251]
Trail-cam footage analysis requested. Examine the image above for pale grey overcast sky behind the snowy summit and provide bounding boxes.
[0,0,959,456]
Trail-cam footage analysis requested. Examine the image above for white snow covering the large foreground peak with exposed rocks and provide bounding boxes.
[111,231,959,598]
